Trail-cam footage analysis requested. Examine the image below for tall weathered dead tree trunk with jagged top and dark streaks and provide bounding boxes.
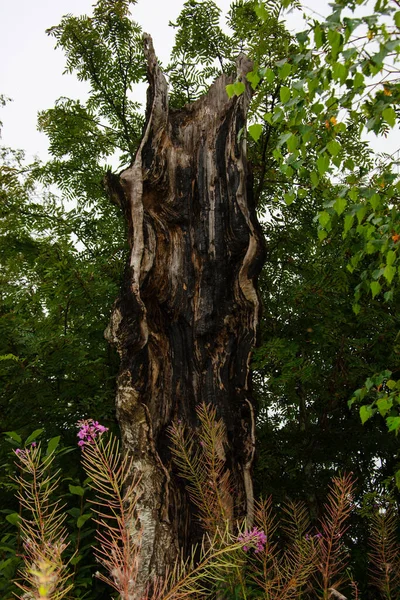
[107,36,264,587]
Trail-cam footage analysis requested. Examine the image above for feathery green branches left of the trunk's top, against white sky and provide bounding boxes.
[39,0,145,172]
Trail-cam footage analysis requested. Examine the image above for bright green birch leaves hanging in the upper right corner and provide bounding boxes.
[241,1,400,301]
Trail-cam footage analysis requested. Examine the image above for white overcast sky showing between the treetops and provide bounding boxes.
[0,0,327,159]
